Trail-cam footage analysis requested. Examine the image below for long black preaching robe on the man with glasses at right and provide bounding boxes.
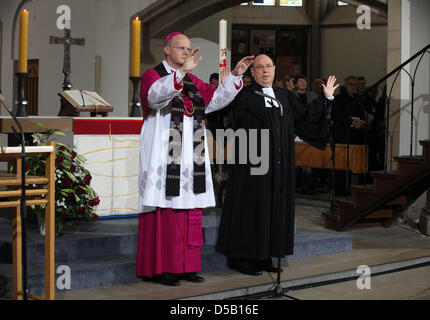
[216,82,331,260]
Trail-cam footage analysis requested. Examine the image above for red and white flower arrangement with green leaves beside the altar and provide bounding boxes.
[26,123,100,234]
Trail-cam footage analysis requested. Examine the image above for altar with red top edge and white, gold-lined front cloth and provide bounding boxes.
[0,117,143,219]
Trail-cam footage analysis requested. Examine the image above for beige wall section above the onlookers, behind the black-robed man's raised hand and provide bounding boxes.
[321,5,387,85]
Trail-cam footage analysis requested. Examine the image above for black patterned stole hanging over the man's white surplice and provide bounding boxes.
[154,63,206,197]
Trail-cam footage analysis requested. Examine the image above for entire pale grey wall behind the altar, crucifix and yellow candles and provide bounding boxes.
[0,0,155,116]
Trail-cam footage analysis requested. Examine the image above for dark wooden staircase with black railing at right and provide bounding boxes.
[324,140,430,231]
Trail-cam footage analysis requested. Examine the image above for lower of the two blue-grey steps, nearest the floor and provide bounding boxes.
[0,229,352,297]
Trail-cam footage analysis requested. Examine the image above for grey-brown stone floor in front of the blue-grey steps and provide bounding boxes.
[56,199,430,300]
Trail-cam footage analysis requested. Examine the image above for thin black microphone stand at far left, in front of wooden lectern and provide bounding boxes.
[0,93,28,300]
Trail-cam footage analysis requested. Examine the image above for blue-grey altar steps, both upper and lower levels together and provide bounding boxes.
[0,210,352,297]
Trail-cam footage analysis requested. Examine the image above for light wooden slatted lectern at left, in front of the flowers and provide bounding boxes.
[0,142,55,300]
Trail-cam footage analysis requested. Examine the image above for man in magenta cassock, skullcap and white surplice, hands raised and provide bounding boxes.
[136,32,253,286]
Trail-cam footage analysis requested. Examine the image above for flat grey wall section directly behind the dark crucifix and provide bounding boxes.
[37,0,97,116]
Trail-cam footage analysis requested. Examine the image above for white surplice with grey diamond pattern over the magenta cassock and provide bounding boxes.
[139,60,243,212]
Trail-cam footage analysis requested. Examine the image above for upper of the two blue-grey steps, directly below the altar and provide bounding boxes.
[0,216,219,265]
